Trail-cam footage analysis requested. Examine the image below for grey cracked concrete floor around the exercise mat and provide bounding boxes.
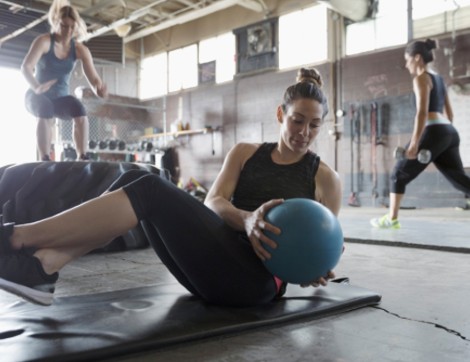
[0,206,470,362]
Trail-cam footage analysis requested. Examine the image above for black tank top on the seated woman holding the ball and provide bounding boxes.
[231,143,320,211]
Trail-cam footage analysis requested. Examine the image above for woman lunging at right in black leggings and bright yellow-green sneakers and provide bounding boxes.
[370,39,470,229]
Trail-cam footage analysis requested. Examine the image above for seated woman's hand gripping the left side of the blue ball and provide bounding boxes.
[244,199,284,260]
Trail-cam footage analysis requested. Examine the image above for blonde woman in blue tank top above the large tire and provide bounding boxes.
[21,0,107,161]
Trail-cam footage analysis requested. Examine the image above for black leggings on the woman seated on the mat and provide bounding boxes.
[110,170,277,307]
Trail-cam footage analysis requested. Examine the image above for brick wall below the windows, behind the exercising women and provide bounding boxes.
[91,36,470,207]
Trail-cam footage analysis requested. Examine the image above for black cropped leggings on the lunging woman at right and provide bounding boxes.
[391,124,470,195]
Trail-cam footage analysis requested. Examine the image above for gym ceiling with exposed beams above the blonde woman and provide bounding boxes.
[0,0,265,68]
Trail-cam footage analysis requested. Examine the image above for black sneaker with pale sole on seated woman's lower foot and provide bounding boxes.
[0,251,59,306]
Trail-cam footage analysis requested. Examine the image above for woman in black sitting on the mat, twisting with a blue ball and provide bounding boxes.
[0,69,342,307]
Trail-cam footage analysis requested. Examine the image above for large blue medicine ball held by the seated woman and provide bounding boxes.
[265,198,343,284]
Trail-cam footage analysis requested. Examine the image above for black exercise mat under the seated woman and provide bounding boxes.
[0,283,381,362]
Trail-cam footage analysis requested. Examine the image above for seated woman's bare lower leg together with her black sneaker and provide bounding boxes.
[0,189,138,305]
